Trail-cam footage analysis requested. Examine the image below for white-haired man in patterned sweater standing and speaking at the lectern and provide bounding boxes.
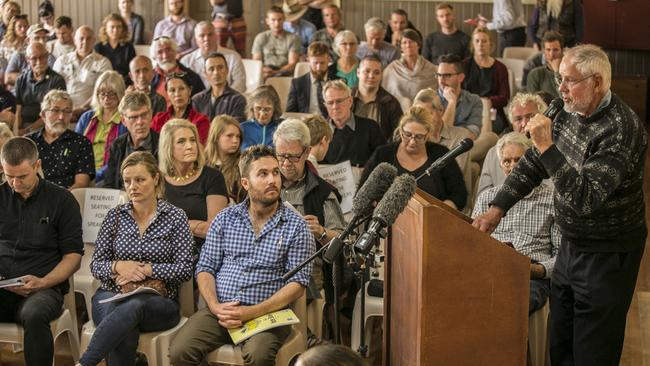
[474,44,648,365]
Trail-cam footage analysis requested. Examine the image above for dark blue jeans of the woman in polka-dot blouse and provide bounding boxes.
[79,289,180,366]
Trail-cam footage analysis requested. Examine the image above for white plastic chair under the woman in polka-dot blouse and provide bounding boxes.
[81,280,194,366]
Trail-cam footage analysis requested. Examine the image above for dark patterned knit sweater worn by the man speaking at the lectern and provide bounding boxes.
[491,94,648,252]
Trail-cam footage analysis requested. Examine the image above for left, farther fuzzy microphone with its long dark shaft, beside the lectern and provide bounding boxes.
[323,163,397,263]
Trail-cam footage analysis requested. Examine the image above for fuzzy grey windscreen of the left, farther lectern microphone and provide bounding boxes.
[352,163,397,216]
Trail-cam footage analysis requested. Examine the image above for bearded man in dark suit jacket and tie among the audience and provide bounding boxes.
[286,42,338,118]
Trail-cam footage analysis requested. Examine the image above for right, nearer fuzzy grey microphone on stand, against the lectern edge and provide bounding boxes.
[354,174,417,255]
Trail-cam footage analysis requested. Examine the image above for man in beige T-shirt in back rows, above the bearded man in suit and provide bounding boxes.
[251,6,300,79]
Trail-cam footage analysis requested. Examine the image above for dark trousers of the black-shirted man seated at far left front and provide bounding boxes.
[0,288,63,366]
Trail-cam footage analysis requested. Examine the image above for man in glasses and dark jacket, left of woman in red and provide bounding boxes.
[102,91,158,189]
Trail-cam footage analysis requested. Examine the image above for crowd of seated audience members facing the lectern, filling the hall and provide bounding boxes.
[0,0,636,366]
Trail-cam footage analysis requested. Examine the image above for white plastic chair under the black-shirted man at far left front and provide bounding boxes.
[0,275,79,365]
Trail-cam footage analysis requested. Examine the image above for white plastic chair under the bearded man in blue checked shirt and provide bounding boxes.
[206,294,307,366]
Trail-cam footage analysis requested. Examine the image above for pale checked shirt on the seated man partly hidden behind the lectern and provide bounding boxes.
[472,185,560,278]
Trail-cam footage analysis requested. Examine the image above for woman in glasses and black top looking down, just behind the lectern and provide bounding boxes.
[359,107,467,210]
